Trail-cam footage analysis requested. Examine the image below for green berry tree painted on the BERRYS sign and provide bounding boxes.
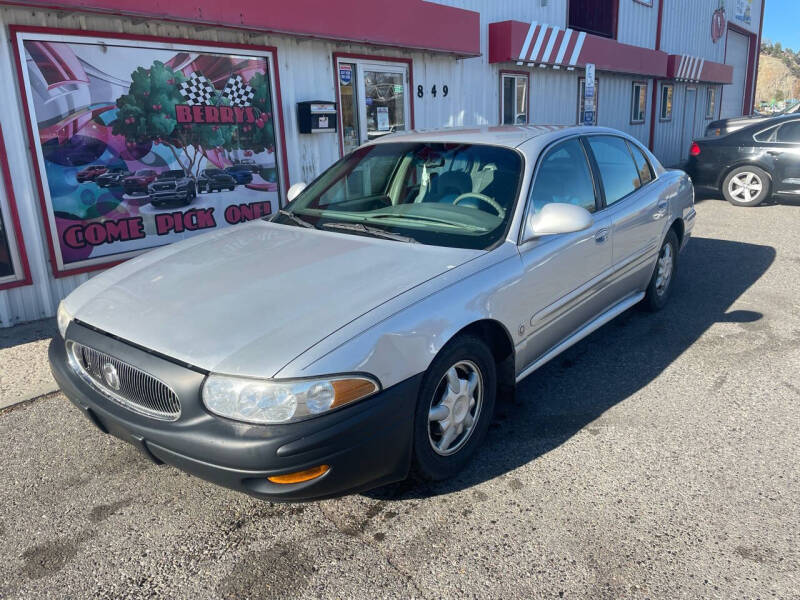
[112,61,236,175]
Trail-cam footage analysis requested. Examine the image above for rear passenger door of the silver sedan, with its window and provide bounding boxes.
[587,135,669,297]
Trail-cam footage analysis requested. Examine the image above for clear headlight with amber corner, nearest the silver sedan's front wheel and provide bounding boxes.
[203,374,379,424]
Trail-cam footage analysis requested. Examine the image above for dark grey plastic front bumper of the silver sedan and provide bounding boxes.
[49,322,422,501]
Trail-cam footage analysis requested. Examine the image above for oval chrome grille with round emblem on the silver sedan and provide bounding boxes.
[67,341,181,421]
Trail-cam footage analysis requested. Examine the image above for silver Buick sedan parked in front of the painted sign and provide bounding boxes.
[50,126,695,500]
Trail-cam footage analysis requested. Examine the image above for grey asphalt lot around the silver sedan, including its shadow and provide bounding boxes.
[0,200,800,600]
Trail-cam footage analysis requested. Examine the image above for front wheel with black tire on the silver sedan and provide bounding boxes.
[411,335,497,481]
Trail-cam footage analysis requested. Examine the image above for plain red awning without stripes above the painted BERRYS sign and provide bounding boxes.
[0,0,481,56]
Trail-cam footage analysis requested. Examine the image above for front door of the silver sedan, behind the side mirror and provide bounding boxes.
[518,137,612,368]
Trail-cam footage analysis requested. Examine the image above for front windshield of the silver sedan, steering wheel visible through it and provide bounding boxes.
[274,142,522,249]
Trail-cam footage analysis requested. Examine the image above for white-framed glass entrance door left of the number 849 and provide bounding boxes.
[337,58,411,154]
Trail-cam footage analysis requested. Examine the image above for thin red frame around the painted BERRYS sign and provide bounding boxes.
[10,25,289,278]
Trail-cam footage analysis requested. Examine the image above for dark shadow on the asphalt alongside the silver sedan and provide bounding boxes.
[366,238,776,499]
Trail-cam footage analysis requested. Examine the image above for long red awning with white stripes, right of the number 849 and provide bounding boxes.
[489,21,733,83]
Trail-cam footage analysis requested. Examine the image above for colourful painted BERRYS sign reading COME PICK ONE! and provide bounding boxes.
[17,32,280,274]
